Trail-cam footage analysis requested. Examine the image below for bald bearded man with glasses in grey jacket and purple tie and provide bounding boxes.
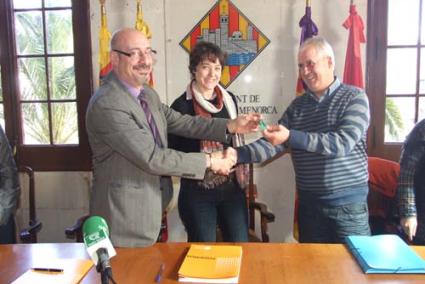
[86,28,260,247]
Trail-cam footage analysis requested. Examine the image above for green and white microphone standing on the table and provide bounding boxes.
[83,216,117,284]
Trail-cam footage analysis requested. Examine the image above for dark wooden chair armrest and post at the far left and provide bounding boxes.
[19,166,43,243]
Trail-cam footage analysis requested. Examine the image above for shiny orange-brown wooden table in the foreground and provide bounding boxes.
[0,243,425,284]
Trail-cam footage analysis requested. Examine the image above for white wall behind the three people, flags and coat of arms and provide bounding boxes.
[14,0,367,242]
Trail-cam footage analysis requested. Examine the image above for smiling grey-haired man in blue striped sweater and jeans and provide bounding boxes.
[232,37,370,243]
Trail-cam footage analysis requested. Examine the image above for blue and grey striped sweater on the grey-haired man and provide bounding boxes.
[237,78,370,205]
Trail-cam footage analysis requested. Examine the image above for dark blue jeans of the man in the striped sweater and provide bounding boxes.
[298,201,370,243]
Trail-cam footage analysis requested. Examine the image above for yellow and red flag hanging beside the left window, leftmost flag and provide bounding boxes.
[99,0,111,84]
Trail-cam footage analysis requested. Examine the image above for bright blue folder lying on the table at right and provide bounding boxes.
[346,235,425,274]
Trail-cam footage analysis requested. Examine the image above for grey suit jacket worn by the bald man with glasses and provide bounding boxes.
[86,72,227,247]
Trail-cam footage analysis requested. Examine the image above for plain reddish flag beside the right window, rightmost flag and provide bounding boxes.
[342,5,366,88]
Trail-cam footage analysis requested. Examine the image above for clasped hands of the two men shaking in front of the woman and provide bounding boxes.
[207,147,238,175]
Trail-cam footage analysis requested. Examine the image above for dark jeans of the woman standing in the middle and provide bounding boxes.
[178,182,248,242]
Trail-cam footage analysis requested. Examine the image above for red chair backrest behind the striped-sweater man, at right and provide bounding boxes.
[368,157,400,234]
